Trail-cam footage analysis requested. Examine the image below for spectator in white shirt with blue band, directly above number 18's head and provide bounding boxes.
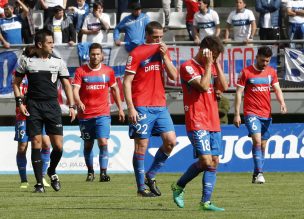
[193,0,221,45]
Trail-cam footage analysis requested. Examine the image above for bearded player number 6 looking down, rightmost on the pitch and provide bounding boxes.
[233,46,287,184]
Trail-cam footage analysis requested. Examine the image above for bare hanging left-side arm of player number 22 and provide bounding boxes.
[123,72,138,124]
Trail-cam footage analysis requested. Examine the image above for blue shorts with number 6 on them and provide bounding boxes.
[245,115,272,140]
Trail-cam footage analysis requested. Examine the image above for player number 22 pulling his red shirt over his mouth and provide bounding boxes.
[123,21,177,197]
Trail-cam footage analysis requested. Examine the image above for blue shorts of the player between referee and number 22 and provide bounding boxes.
[79,116,111,141]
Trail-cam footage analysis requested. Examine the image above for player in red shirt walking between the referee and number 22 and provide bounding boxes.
[73,43,125,182]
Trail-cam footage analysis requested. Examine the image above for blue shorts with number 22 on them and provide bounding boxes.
[129,106,174,139]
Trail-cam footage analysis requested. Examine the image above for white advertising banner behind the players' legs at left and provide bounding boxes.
[0,126,134,173]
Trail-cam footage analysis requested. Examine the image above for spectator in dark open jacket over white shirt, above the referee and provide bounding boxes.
[44,5,76,46]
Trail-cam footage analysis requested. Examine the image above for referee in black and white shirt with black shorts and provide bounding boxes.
[13,30,75,193]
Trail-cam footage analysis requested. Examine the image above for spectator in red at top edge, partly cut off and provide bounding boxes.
[184,0,199,41]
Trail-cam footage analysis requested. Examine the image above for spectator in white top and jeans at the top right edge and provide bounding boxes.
[287,1,304,48]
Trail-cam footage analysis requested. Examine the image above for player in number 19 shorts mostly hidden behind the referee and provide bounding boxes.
[14,46,51,189]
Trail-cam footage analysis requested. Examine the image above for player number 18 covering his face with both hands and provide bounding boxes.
[171,36,228,211]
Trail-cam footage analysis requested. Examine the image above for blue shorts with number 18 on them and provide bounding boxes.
[187,130,222,158]
